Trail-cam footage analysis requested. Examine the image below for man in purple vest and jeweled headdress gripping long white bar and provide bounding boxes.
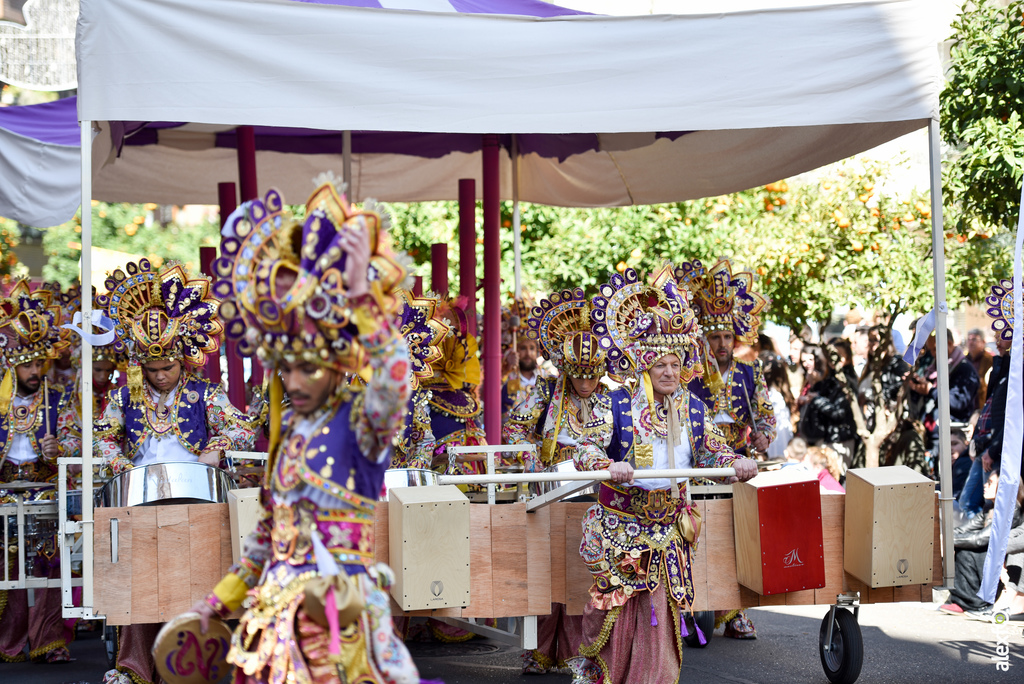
[569,268,757,684]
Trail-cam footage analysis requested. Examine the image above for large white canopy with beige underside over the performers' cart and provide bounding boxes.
[78,0,940,206]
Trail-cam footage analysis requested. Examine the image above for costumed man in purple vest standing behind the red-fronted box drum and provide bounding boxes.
[676,259,776,639]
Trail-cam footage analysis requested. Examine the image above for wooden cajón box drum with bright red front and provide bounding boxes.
[732,467,825,596]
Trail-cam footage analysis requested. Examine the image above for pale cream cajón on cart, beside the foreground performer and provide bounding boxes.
[388,484,470,610]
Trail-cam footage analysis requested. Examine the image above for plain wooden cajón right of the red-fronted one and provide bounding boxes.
[843,466,935,589]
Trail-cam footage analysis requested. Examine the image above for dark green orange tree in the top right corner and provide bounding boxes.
[940,0,1024,234]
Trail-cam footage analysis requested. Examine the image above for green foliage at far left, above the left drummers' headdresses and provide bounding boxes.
[43,201,219,287]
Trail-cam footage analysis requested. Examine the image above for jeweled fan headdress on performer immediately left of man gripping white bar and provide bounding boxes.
[526,288,607,378]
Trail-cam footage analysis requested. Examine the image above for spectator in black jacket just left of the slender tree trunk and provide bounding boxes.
[797,345,857,472]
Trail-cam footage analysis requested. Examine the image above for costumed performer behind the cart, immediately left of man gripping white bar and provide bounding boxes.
[503,290,611,674]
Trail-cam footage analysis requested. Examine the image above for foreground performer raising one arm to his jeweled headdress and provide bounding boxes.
[194,182,430,684]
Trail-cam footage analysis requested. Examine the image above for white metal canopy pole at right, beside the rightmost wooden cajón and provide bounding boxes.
[928,119,953,587]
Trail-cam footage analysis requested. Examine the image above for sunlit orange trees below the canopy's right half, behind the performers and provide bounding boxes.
[390,162,991,328]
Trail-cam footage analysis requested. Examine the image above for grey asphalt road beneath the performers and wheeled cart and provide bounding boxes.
[8,603,1024,684]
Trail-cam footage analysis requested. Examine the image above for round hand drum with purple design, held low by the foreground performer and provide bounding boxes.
[153,612,231,684]
